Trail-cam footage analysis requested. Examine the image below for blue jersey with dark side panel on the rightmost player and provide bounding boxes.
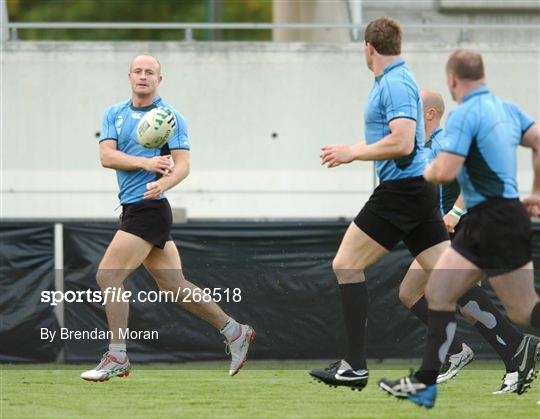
[443,86,534,209]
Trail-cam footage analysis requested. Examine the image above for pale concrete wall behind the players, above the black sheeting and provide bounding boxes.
[1,40,540,219]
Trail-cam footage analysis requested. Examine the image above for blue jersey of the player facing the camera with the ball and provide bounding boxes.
[99,96,189,204]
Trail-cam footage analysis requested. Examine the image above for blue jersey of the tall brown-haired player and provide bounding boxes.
[364,58,426,182]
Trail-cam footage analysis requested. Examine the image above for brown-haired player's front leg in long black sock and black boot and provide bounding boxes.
[310,223,388,390]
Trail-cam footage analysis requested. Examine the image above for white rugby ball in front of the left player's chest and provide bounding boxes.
[137,107,176,148]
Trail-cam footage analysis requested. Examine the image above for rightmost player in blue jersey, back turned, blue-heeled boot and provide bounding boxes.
[379,50,540,408]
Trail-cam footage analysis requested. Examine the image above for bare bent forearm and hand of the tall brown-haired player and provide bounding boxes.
[321,118,416,167]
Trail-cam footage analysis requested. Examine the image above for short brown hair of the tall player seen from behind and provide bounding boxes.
[364,17,401,55]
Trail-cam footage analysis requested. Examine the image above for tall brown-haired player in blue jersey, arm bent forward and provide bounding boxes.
[310,18,449,390]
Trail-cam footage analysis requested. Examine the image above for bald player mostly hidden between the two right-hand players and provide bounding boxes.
[399,89,524,394]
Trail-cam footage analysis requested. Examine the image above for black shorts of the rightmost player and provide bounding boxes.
[452,198,532,276]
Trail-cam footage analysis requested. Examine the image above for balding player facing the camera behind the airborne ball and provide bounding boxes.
[81,54,255,381]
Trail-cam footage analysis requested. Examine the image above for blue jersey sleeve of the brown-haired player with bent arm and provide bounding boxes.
[381,78,418,123]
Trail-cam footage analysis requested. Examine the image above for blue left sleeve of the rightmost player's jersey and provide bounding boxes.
[441,107,476,157]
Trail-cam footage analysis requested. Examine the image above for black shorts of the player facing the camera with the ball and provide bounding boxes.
[120,199,172,249]
